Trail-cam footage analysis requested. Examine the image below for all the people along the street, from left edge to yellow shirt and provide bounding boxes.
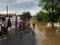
[0,18,36,38]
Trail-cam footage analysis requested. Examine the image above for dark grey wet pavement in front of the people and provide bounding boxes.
[0,30,36,45]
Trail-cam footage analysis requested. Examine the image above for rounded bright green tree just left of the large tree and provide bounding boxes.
[36,11,50,22]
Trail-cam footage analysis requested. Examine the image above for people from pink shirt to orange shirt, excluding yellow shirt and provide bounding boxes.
[17,18,30,31]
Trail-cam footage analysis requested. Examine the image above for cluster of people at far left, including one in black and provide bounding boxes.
[0,18,11,38]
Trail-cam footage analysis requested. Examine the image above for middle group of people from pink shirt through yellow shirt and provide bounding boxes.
[17,18,36,31]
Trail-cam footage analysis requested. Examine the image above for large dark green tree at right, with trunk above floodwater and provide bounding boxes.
[39,0,60,27]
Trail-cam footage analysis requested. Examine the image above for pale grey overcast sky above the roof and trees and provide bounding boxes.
[0,0,41,15]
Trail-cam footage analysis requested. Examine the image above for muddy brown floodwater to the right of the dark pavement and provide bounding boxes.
[35,22,60,45]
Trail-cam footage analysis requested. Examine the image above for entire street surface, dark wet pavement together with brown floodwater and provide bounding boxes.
[0,23,60,45]
